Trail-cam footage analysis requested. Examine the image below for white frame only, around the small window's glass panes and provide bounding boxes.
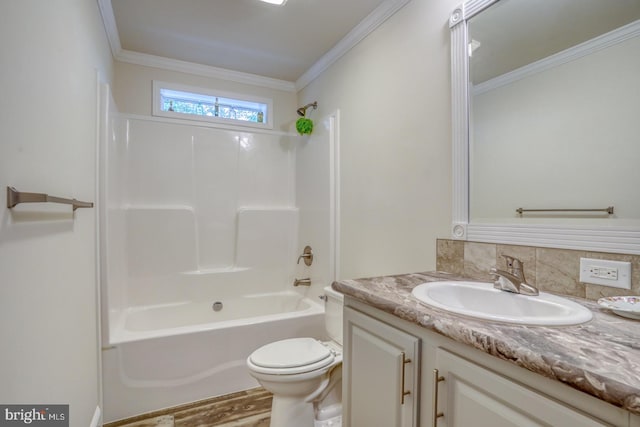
[151,80,273,129]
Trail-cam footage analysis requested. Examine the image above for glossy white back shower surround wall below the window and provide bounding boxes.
[106,115,298,307]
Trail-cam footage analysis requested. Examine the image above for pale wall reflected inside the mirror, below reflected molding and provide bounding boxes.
[470,37,640,221]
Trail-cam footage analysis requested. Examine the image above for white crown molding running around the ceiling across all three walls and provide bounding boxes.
[97,0,410,92]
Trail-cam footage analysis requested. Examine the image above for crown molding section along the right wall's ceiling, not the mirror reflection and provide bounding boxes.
[295,0,411,90]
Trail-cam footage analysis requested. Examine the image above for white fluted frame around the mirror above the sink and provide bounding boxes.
[449,0,640,254]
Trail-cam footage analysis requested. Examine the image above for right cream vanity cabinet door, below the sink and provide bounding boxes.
[434,348,609,427]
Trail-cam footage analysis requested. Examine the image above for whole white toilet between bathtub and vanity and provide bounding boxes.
[247,287,344,427]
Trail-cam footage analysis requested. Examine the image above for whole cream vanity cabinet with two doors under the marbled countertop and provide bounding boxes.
[343,297,640,427]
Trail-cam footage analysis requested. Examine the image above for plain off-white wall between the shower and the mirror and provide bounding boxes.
[299,0,460,278]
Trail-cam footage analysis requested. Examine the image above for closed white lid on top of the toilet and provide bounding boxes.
[249,338,333,369]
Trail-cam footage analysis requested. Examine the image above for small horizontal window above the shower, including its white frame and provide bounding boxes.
[153,81,273,128]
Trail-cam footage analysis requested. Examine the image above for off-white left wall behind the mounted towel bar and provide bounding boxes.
[0,0,112,427]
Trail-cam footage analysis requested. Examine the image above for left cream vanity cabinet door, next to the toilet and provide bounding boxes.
[342,307,420,427]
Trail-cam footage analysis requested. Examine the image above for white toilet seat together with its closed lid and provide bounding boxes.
[248,338,335,375]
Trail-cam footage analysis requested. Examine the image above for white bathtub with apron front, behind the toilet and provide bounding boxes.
[102,291,326,422]
